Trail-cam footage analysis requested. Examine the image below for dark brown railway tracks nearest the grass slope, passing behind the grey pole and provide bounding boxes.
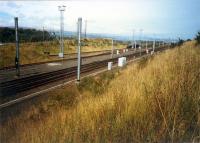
[0,48,170,109]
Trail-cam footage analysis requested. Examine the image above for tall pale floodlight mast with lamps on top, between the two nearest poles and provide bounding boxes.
[58,5,66,58]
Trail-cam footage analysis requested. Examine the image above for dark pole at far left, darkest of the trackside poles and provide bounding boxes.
[15,17,20,77]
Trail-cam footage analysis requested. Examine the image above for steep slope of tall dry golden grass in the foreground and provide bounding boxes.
[1,41,200,143]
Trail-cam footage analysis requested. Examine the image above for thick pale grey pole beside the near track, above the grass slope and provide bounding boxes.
[77,18,82,82]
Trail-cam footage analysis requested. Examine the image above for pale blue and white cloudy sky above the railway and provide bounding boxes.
[0,0,200,39]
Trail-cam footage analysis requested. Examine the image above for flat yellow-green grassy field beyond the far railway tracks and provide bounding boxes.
[0,39,126,68]
